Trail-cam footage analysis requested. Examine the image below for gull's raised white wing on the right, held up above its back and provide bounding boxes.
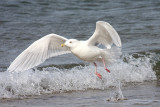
[88,21,121,49]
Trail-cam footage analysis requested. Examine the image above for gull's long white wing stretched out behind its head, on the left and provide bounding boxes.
[8,34,70,72]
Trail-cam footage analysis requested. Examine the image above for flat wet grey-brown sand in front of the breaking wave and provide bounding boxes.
[0,81,160,107]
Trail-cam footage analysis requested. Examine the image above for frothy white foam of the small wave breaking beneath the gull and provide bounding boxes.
[0,55,156,99]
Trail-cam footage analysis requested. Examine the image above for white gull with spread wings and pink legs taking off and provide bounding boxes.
[7,21,122,78]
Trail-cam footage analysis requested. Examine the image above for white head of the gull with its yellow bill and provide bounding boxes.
[61,39,78,48]
